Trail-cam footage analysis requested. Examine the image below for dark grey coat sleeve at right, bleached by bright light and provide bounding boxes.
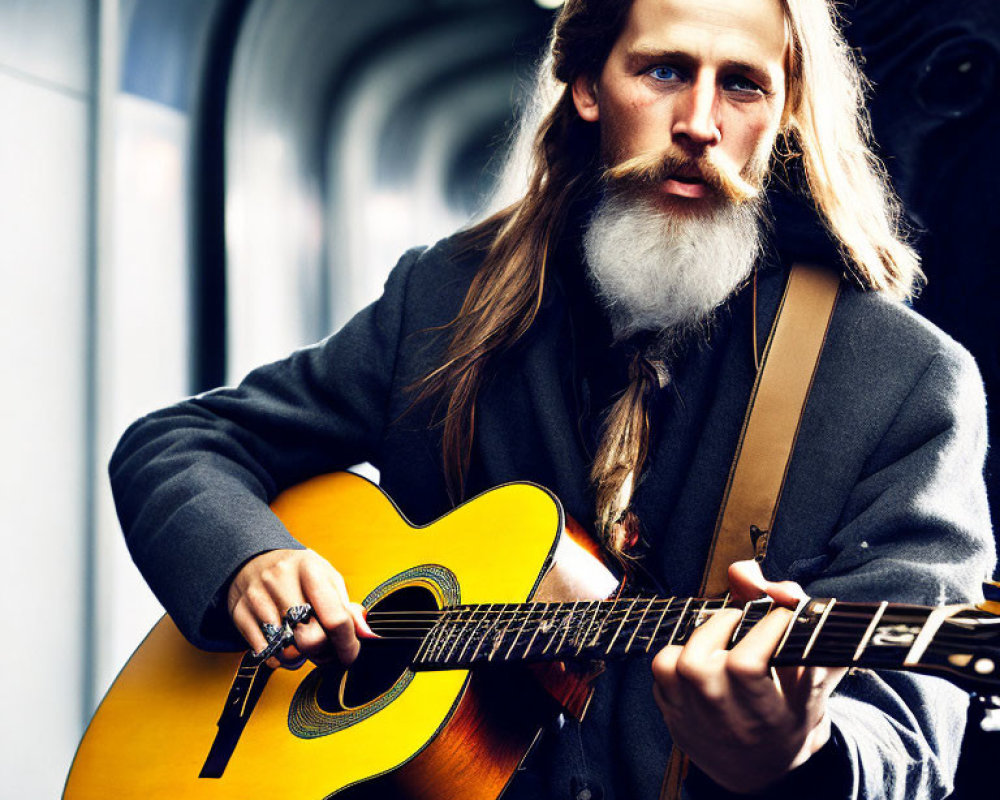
[805,342,995,800]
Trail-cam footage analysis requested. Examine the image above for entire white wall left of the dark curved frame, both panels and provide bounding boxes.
[0,0,190,798]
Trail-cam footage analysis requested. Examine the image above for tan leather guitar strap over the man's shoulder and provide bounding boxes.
[660,264,840,800]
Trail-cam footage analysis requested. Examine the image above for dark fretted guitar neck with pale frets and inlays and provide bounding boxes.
[369,597,995,683]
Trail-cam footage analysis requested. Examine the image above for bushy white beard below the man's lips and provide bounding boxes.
[583,193,761,340]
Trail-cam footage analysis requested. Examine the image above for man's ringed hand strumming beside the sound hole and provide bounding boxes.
[227,550,374,669]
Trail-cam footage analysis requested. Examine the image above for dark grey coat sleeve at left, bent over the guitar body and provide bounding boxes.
[110,245,421,649]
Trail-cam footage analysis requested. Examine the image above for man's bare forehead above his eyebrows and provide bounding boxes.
[616,0,787,67]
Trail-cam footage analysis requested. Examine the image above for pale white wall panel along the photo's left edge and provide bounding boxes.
[0,0,91,798]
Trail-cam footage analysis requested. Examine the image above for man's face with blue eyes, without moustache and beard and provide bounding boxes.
[573,0,787,209]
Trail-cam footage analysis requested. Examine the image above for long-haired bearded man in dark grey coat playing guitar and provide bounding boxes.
[112,0,993,798]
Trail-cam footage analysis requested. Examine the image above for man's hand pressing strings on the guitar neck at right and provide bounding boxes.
[653,561,846,793]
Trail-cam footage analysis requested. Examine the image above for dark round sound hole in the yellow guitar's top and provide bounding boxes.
[316,585,438,713]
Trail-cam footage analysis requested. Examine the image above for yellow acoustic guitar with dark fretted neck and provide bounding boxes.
[64,473,1000,800]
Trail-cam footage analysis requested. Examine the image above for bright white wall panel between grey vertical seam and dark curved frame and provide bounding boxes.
[94,94,190,697]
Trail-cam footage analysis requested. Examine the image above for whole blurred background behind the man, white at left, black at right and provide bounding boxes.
[0,0,1000,798]
